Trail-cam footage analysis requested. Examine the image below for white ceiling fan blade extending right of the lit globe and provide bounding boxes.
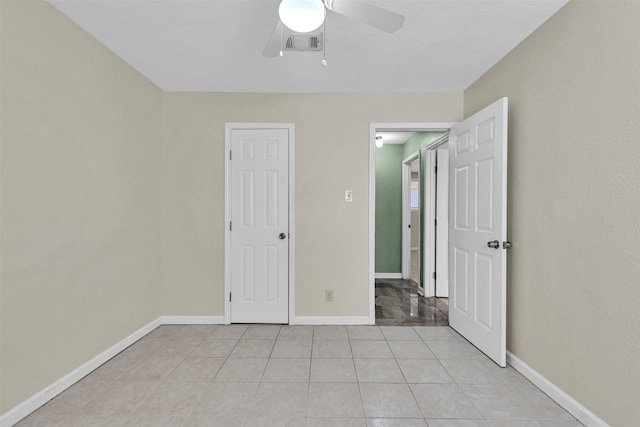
[325,0,404,33]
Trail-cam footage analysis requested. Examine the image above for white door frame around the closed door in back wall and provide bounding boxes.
[224,123,296,325]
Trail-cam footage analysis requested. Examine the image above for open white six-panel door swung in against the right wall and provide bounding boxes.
[449,98,509,367]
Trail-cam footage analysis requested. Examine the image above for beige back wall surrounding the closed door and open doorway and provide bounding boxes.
[162,93,462,316]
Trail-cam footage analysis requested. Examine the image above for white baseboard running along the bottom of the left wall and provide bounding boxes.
[0,317,161,427]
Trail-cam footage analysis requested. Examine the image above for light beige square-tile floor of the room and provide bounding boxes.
[18,325,582,427]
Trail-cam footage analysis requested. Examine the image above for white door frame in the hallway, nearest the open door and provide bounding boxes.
[423,133,449,297]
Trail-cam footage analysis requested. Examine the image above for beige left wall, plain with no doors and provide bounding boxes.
[0,0,162,413]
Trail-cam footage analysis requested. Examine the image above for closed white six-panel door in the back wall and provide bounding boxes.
[229,129,289,323]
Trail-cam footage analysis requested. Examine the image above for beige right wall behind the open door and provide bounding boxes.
[464,1,640,426]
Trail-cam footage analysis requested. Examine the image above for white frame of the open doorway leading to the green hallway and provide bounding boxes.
[369,122,456,325]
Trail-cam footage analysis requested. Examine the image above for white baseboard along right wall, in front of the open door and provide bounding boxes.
[507,351,609,427]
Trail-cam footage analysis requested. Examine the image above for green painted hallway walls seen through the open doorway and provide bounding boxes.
[375,132,444,285]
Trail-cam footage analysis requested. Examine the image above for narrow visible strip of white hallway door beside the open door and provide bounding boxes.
[436,148,449,298]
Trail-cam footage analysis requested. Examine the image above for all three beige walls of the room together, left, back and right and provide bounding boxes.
[0,0,640,426]
